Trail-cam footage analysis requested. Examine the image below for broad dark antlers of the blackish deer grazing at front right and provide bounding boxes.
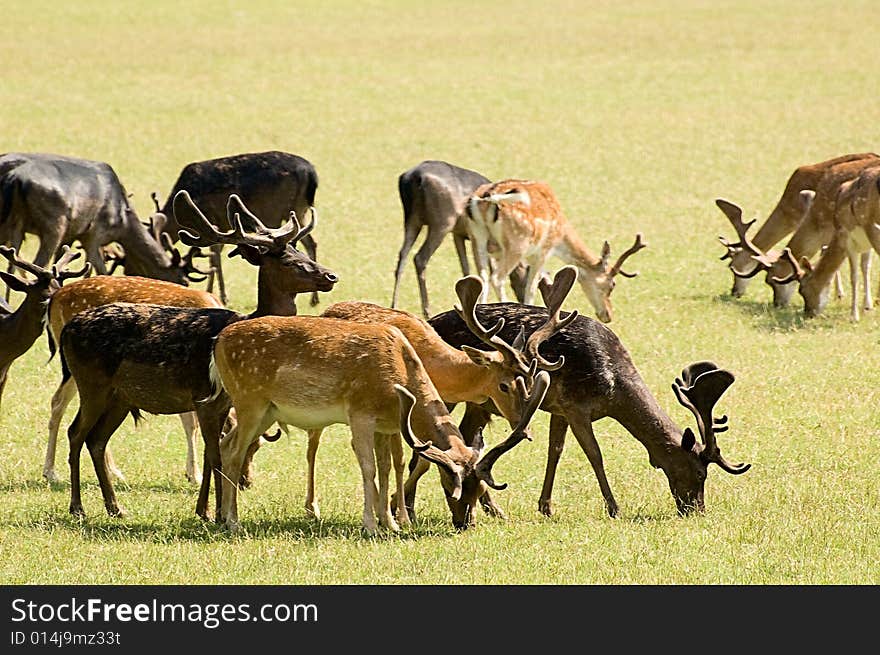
[672,361,751,475]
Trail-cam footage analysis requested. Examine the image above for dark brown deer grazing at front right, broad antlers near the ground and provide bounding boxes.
[426,282,750,517]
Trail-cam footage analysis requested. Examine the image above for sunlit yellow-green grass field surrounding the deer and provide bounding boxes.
[0,0,880,584]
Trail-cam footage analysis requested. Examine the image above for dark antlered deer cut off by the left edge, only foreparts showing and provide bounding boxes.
[0,246,91,410]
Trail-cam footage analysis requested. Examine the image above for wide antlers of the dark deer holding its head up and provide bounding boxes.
[173,189,314,250]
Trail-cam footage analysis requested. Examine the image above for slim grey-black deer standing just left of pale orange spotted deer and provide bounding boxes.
[391,160,489,318]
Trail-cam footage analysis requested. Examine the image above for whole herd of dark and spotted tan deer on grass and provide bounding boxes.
[0,146,880,533]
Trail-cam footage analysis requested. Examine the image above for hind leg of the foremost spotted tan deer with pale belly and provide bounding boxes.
[217,408,275,533]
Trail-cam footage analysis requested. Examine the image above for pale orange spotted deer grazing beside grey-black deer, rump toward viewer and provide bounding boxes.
[467,179,646,323]
